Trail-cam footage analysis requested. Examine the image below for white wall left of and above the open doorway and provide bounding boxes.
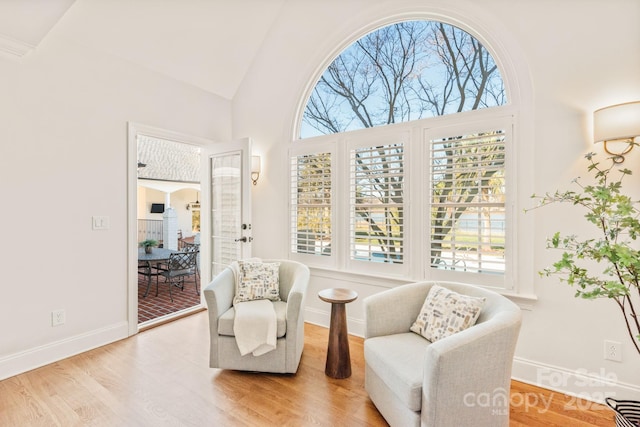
[0,31,231,378]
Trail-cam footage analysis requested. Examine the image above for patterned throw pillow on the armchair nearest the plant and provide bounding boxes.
[411,285,485,342]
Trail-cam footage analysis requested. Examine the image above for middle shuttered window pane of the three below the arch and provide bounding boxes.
[350,144,404,264]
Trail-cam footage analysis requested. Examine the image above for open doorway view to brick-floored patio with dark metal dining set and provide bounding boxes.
[129,125,209,328]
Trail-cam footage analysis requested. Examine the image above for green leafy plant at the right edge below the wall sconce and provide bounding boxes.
[532,153,640,355]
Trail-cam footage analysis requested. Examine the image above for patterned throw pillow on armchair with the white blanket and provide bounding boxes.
[233,261,280,304]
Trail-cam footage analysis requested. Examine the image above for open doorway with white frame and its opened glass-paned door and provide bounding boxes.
[127,122,253,335]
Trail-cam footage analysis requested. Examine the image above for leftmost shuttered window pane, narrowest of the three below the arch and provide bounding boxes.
[291,153,331,256]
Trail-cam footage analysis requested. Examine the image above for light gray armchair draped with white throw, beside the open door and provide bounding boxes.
[204,260,309,373]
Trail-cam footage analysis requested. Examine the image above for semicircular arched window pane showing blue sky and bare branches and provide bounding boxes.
[300,21,506,138]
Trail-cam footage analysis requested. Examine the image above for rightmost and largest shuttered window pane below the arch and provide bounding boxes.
[430,130,505,274]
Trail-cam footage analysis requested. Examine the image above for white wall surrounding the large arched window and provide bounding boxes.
[233,0,640,400]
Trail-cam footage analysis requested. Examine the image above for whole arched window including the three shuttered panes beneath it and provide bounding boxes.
[290,21,513,288]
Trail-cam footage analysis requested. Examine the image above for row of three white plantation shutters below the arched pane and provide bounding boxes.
[289,114,526,289]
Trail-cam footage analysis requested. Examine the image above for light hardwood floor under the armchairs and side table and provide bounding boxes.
[0,312,615,427]
